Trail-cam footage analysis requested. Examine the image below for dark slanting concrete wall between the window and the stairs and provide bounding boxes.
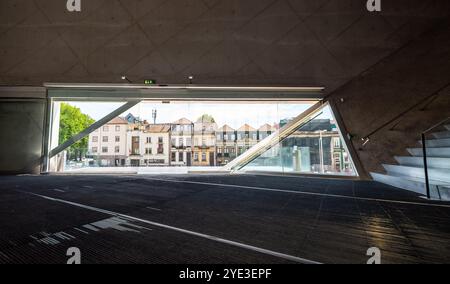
[330,20,450,172]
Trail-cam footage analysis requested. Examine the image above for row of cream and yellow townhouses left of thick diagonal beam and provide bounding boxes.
[89,114,276,167]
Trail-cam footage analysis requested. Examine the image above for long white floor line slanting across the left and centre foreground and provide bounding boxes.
[20,191,321,264]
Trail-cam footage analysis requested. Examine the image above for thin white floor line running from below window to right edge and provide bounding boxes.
[140,177,450,208]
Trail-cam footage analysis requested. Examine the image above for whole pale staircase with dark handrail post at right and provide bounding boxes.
[371,124,450,200]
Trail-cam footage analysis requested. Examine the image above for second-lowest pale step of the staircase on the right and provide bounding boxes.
[383,165,450,184]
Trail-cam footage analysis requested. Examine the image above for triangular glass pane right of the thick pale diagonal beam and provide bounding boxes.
[241,106,356,176]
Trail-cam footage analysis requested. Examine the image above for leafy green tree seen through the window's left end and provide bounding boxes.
[59,103,95,159]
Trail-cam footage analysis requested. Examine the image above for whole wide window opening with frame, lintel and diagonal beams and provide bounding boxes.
[44,85,357,176]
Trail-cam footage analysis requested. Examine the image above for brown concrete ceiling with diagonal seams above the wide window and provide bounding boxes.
[0,0,450,92]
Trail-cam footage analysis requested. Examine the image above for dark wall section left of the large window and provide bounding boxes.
[0,88,46,174]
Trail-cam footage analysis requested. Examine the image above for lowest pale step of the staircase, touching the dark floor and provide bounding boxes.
[370,173,442,200]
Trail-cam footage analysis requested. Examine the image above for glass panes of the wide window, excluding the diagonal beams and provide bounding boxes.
[51,98,355,175]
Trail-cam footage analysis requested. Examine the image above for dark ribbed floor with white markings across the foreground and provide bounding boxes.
[0,175,450,263]
